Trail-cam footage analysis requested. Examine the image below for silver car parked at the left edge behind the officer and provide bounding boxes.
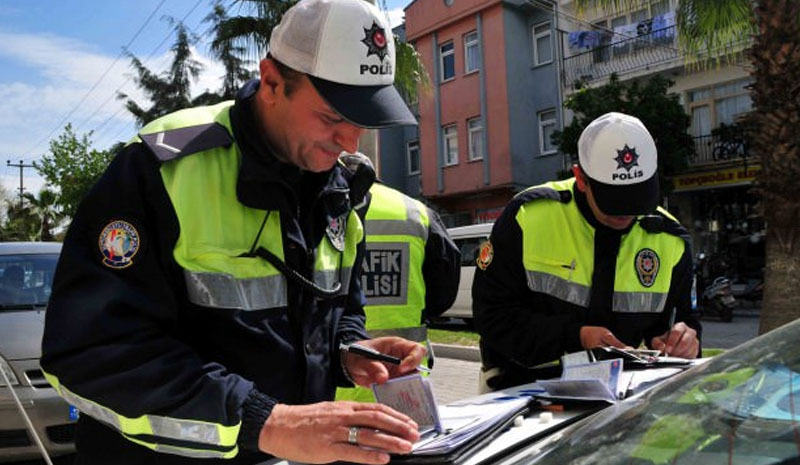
[0,242,77,462]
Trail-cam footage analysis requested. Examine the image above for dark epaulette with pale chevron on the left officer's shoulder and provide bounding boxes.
[139,123,233,162]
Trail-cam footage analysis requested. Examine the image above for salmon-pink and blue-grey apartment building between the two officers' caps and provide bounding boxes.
[380,0,564,226]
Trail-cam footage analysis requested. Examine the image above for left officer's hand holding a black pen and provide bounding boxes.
[342,336,426,386]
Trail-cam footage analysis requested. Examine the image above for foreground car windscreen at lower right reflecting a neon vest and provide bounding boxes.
[491,319,800,465]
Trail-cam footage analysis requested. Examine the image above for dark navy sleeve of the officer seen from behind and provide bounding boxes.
[422,209,461,317]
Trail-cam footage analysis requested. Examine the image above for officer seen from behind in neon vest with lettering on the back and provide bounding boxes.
[336,169,461,402]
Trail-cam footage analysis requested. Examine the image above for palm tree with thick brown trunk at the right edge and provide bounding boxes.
[576,0,800,333]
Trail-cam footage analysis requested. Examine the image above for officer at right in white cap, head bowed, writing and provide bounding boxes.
[472,113,701,389]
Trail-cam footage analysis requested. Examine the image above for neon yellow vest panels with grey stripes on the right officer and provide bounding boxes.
[516,179,684,313]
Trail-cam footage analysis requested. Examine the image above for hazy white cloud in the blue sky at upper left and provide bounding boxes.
[0,30,224,196]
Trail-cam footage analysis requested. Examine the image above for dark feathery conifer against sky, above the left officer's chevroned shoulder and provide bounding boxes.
[117,22,203,127]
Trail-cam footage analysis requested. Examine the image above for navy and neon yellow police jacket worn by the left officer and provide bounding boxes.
[42,89,372,463]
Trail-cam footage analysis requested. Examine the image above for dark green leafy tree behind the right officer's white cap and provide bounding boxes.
[553,74,694,195]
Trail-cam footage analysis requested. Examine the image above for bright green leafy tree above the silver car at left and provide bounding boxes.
[34,124,115,217]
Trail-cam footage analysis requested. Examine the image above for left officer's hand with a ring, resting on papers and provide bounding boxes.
[258,402,419,464]
